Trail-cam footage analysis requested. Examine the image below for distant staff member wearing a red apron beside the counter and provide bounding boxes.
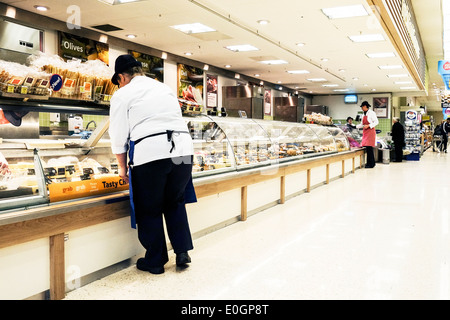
[357,101,378,168]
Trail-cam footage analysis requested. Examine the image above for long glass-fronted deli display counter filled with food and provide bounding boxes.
[0,110,350,211]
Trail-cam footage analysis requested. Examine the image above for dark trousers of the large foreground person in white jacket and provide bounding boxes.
[131,156,194,267]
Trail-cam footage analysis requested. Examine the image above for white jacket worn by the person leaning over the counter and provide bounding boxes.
[109,76,194,166]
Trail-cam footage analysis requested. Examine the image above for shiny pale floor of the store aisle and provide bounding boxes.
[66,150,450,300]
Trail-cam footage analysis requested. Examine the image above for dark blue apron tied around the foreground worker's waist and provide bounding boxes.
[128,131,197,229]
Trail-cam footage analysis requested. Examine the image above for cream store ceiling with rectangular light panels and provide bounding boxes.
[2,0,444,111]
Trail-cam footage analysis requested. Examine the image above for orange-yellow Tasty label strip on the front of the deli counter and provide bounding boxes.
[48,177,128,202]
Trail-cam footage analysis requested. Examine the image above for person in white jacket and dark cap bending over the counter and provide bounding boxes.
[109,55,196,274]
